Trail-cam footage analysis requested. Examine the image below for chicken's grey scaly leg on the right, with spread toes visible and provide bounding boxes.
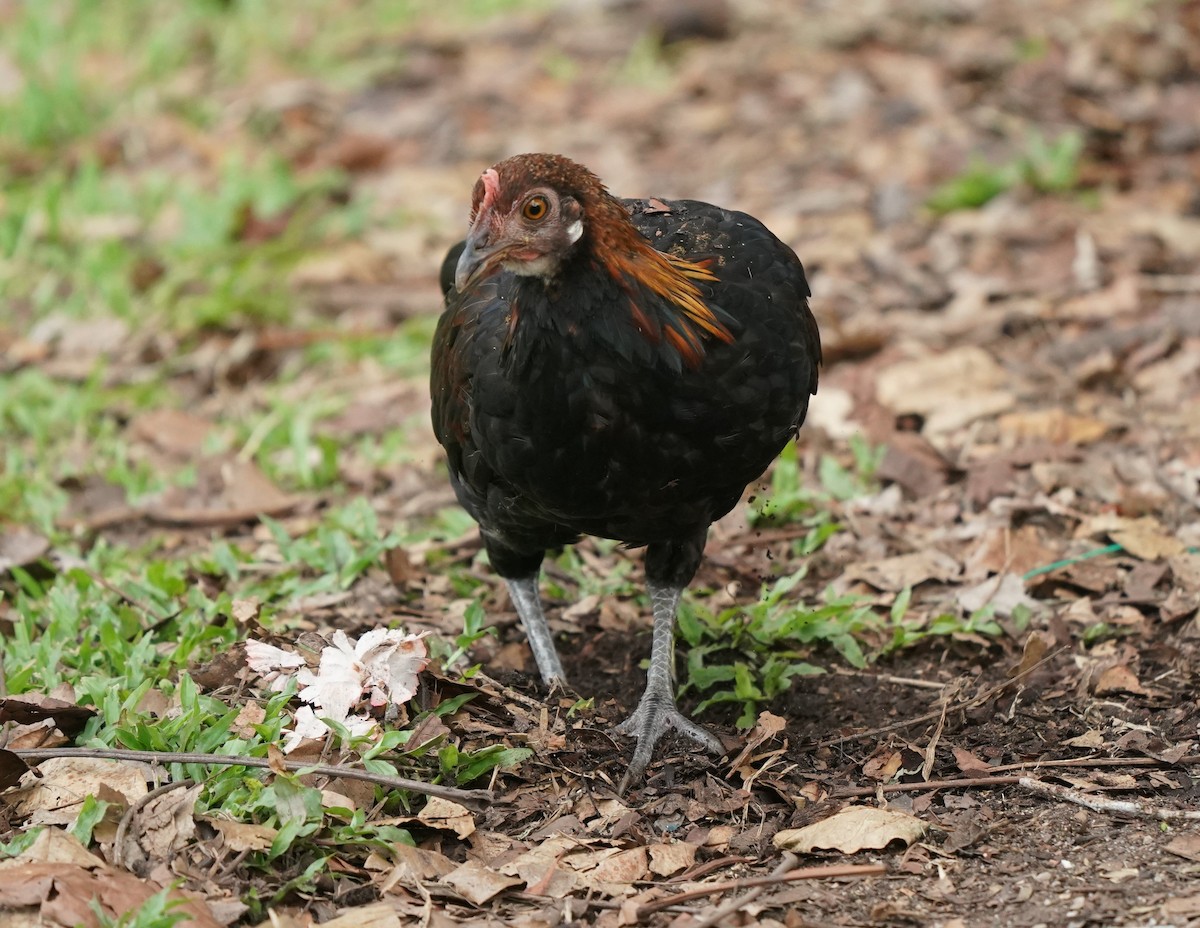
[617,581,725,792]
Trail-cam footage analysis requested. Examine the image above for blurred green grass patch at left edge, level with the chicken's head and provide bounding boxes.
[0,149,365,333]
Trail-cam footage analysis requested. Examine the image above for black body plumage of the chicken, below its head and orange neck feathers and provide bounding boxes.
[431,200,821,585]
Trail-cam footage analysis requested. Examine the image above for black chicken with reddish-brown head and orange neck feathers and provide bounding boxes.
[431,155,821,785]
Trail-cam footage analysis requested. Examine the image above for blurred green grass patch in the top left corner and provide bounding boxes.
[0,0,506,151]
